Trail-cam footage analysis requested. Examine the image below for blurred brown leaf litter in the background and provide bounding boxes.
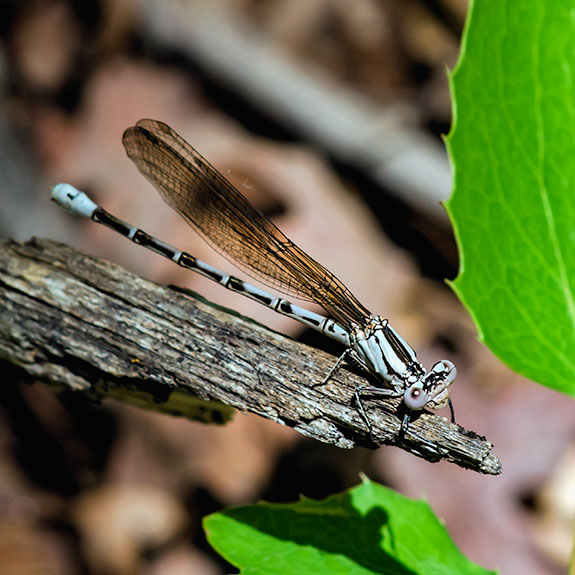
[0,0,575,575]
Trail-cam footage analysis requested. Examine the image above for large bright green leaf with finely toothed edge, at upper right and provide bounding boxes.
[447,0,575,395]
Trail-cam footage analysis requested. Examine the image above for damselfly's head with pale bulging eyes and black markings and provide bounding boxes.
[403,359,457,411]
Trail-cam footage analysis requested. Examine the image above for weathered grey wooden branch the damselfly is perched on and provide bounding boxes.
[0,240,501,474]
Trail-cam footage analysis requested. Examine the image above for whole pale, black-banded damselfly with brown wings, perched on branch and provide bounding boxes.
[52,120,457,434]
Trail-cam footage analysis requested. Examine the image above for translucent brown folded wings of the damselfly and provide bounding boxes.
[123,120,371,327]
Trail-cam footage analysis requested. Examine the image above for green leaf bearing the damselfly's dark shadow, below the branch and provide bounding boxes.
[204,479,492,575]
